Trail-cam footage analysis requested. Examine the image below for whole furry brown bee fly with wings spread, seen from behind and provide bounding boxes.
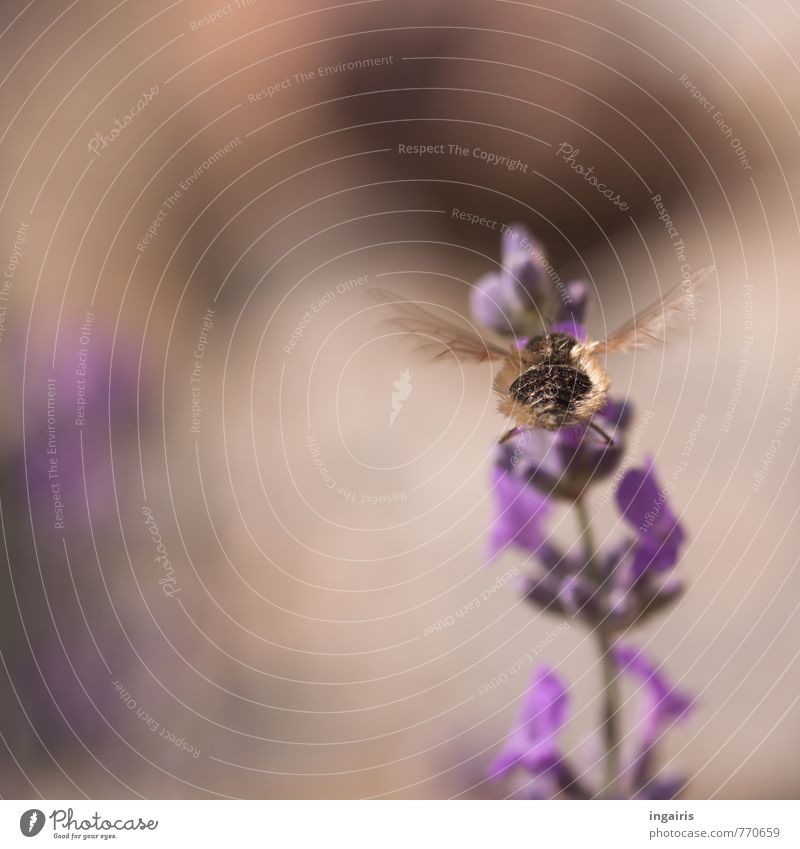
[372,266,714,443]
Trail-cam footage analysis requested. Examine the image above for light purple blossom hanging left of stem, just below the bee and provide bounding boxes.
[489,460,550,557]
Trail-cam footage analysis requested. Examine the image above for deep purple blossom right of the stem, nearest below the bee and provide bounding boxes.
[617,459,686,578]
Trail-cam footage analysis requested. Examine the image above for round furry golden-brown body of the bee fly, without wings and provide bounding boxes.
[495,333,609,430]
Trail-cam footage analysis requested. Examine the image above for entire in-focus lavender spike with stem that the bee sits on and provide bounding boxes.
[472,226,690,799]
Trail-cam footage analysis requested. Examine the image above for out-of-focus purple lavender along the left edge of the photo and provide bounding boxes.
[0,322,146,749]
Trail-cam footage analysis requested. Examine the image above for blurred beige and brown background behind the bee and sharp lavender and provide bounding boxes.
[0,0,800,798]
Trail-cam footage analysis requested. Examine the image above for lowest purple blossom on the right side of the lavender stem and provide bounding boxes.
[613,645,692,799]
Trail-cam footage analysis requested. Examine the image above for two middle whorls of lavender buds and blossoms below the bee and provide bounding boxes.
[491,438,683,631]
